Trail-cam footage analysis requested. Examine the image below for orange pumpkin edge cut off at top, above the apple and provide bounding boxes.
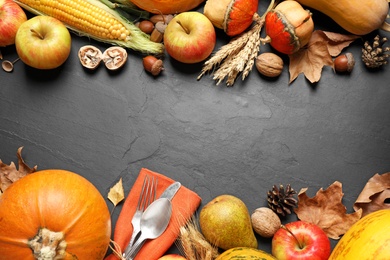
[130,0,204,14]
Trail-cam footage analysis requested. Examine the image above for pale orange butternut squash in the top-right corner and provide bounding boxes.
[296,0,389,35]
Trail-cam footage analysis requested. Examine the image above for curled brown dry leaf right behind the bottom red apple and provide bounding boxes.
[294,181,362,239]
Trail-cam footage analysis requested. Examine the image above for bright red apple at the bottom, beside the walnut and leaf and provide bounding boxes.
[272,221,331,260]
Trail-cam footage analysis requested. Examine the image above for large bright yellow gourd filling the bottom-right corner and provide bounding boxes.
[329,209,390,260]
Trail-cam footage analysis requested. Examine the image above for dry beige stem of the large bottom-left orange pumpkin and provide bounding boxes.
[28,228,66,260]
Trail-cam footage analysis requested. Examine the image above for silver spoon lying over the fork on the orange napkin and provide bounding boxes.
[125,198,172,260]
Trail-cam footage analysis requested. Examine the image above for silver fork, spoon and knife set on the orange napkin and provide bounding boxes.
[123,175,181,260]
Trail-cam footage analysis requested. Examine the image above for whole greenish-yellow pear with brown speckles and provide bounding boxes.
[199,194,257,250]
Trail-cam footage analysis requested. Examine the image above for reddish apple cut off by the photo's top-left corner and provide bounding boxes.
[0,0,27,47]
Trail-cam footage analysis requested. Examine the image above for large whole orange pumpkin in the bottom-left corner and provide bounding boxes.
[0,170,111,260]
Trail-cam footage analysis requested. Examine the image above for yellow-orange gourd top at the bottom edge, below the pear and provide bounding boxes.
[215,247,276,260]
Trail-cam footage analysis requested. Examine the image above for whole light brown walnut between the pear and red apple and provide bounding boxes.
[251,207,282,238]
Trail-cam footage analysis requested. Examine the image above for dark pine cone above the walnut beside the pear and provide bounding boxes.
[267,184,297,216]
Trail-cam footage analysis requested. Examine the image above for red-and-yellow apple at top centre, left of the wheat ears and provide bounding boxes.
[164,12,216,63]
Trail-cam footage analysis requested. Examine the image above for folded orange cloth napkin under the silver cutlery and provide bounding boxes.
[105,168,201,260]
